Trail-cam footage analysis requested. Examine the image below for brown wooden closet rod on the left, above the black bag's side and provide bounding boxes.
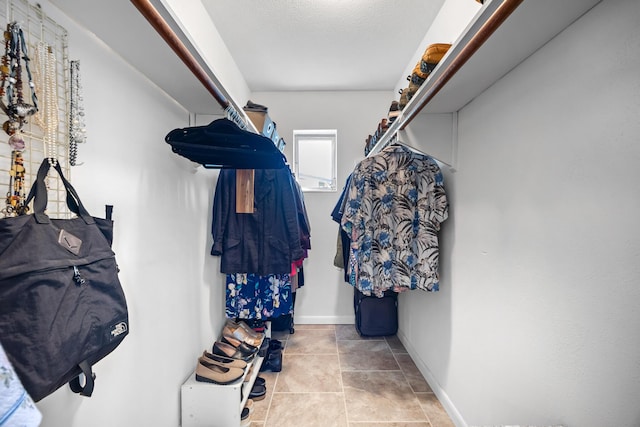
[131,0,229,108]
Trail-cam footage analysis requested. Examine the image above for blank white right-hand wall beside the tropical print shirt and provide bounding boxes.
[400,0,640,427]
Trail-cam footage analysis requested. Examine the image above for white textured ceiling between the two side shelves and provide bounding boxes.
[202,0,444,91]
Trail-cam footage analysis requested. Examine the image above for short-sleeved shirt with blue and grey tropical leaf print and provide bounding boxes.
[342,145,448,296]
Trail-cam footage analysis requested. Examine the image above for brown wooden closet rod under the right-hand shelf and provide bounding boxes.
[400,0,534,130]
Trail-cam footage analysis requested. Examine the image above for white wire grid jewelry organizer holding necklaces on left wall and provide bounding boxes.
[0,0,71,218]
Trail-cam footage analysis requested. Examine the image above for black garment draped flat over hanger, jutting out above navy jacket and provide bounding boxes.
[165,119,286,169]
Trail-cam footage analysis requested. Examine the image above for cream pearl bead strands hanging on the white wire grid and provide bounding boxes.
[33,43,58,166]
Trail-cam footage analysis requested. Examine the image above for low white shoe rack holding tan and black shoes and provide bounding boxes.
[180,325,271,427]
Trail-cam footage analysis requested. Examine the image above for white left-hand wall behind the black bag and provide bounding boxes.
[33,2,224,427]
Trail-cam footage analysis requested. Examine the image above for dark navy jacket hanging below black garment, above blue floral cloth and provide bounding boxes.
[211,169,305,276]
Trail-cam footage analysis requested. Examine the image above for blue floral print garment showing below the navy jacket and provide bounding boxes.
[226,273,293,320]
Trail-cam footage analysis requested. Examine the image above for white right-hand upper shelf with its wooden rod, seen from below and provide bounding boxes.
[369,0,600,155]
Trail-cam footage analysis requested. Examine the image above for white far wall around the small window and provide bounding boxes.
[251,92,393,323]
